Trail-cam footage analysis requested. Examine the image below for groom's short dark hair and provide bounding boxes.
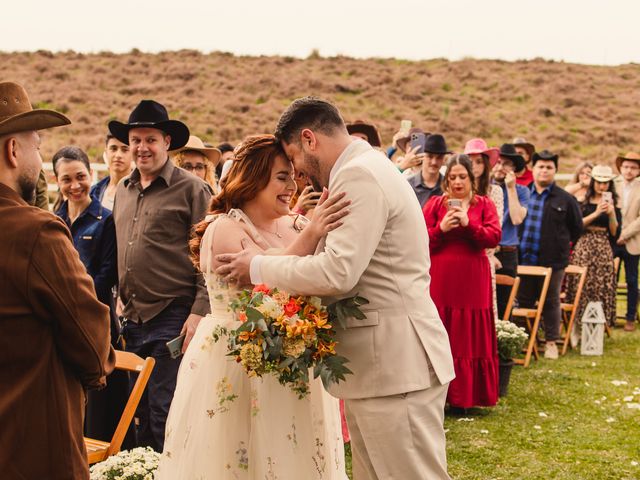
[275,97,347,144]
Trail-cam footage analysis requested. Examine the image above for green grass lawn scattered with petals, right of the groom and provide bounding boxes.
[347,328,640,480]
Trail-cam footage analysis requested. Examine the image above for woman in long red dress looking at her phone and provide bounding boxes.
[424,154,501,409]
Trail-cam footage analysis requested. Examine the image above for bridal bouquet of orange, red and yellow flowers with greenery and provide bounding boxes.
[219,285,369,398]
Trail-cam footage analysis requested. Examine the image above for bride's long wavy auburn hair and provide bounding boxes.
[189,135,286,269]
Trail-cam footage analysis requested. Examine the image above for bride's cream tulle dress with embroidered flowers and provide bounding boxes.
[155,210,347,480]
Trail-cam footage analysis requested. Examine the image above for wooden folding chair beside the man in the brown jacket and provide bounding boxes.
[84,350,156,464]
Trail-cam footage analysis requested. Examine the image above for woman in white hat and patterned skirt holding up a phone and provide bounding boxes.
[569,165,621,332]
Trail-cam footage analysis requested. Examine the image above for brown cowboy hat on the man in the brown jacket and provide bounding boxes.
[0,82,71,135]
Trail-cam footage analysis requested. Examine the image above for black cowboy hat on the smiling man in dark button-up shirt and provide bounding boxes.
[109,100,189,150]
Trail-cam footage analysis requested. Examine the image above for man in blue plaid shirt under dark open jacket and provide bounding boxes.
[518,150,582,359]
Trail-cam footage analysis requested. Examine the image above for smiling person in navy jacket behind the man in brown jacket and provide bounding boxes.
[52,146,131,448]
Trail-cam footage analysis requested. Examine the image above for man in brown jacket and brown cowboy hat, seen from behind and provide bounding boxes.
[0,83,115,480]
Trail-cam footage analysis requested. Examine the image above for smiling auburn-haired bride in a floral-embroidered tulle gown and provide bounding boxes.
[155,135,348,480]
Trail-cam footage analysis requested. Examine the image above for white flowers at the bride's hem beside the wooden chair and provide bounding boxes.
[90,447,160,480]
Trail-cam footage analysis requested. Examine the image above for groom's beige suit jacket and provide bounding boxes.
[258,140,456,399]
